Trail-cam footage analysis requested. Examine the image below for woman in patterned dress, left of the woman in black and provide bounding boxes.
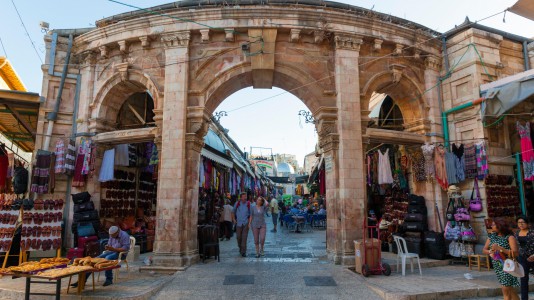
[482,218,519,300]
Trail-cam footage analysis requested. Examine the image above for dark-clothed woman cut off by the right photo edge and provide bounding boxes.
[515,216,534,300]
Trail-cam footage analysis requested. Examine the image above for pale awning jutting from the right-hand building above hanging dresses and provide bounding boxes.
[480,70,534,120]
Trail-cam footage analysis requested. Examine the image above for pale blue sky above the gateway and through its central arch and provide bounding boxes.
[0,0,534,164]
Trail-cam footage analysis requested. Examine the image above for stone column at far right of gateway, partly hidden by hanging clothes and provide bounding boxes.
[422,56,447,232]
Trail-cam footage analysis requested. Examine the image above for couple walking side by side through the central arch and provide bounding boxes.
[232,192,268,258]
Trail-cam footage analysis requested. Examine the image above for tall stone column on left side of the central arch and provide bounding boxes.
[153,31,198,268]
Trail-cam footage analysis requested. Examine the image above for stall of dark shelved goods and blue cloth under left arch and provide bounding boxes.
[98,142,158,253]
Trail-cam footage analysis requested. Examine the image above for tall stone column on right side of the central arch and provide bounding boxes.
[325,34,366,265]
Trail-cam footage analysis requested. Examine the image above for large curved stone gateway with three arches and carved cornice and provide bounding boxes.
[53,0,440,267]
